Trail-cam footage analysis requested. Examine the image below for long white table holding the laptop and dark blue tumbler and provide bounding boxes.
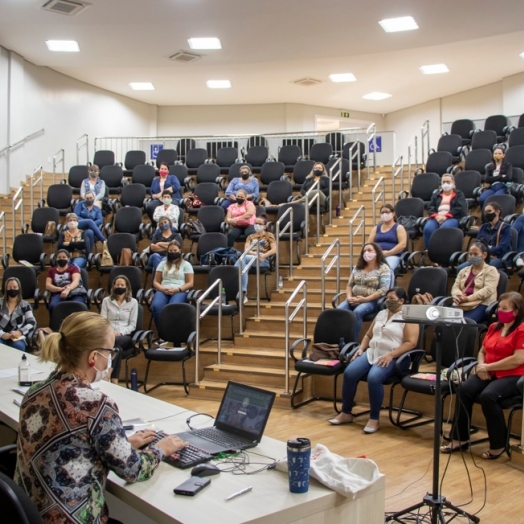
[0,346,385,524]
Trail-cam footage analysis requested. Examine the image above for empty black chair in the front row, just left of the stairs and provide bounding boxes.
[141,304,198,395]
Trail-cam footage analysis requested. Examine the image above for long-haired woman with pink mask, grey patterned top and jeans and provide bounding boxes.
[338,242,391,340]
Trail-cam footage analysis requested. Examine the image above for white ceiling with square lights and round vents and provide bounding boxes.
[0,0,524,114]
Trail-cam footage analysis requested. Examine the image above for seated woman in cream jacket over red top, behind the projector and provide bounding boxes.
[451,242,500,322]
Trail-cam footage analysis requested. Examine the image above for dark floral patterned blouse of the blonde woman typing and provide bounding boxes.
[15,371,163,524]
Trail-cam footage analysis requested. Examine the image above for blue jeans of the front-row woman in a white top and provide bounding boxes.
[342,352,410,420]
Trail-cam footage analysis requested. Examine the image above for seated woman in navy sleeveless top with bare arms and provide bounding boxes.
[368,204,408,271]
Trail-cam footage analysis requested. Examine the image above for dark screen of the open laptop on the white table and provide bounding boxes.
[215,382,275,442]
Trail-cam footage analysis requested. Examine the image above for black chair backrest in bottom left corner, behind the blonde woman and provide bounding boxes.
[0,473,44,524]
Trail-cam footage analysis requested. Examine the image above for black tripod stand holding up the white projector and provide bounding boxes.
[385,320,480,524]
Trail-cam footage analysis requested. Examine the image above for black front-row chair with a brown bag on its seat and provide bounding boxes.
[289,309,357,413]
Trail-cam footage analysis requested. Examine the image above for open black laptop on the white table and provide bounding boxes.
[177,382,275,455]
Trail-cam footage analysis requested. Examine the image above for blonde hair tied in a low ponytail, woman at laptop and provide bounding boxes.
[40,311,111,373]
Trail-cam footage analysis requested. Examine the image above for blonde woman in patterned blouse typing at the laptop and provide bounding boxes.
[15,311,185,523]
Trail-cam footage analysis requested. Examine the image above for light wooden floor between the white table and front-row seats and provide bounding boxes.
[152,386,524,524]
